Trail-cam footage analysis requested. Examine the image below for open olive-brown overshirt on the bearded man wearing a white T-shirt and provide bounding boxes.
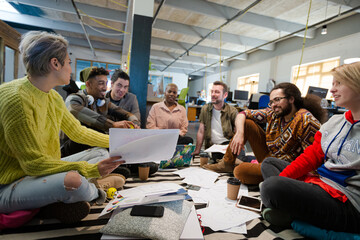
[199,103,238,149]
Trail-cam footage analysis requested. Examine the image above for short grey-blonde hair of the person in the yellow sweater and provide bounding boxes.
[19,31,69,76]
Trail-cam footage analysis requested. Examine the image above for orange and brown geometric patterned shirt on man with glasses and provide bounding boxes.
[244,108,320,162]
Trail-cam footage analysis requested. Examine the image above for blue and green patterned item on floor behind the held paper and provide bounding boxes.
[159,145,195,169]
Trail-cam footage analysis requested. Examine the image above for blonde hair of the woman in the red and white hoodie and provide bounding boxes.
[331,62,360,93]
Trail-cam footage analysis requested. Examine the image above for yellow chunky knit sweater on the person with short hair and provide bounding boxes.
[0,77,109,184]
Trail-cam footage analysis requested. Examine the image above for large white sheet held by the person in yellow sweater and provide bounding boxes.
[109,128,179,164]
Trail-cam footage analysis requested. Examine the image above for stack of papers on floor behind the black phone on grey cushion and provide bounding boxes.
[99,183,187,217]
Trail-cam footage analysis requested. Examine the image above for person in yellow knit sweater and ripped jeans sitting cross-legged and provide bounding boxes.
[0,32,124,223]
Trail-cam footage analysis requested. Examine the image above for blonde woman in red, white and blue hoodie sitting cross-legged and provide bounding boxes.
[260,62,360,233]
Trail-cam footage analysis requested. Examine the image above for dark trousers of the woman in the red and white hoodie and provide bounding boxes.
[260,158,360,233]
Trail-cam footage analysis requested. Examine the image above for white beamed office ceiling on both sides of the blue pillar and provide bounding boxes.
[0,0,360,77]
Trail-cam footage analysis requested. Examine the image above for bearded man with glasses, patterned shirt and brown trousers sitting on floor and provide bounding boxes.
[205,83,326,184]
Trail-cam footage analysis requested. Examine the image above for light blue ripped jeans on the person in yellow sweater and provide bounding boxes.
[0,147,109,213]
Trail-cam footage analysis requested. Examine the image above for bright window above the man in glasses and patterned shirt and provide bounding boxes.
[291,57,340,99]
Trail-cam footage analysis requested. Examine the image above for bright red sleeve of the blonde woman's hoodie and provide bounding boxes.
[279,131,325,179]
